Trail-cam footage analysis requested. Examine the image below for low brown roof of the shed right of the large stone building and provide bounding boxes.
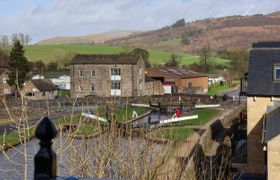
[147,67,207,79]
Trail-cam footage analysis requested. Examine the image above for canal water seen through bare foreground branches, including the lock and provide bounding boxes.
[0,114,167,180]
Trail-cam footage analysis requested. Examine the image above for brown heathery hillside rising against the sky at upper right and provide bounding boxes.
[104,12,280,52]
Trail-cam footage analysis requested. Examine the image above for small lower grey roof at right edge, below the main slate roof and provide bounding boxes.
[264,107,280,142]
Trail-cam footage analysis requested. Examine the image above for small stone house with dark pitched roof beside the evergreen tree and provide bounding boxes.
[21,79,57,100]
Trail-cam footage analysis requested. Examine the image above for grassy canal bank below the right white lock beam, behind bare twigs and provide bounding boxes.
[157,127,195,142]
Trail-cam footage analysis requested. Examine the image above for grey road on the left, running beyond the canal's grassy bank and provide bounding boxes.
[0,106,96,135]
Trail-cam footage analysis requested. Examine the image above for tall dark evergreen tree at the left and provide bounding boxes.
[8,40,30,88]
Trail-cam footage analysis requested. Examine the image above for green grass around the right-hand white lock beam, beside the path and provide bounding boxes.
[174,109,220,126]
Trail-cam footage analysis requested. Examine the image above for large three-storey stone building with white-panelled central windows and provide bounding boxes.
[70,54,145,98]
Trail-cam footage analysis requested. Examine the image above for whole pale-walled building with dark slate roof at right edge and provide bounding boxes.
[246,42,280,179]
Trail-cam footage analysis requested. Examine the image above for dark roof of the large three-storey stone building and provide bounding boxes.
[70,54,139,64]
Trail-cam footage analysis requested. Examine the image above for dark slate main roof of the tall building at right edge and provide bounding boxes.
[247,42,280,96]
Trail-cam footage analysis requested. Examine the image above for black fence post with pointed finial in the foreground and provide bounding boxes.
[34,117,57,180]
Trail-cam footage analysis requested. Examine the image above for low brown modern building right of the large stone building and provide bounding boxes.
[146,68,208,94]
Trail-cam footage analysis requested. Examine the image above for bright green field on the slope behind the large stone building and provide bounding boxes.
[26,44,229,65]
